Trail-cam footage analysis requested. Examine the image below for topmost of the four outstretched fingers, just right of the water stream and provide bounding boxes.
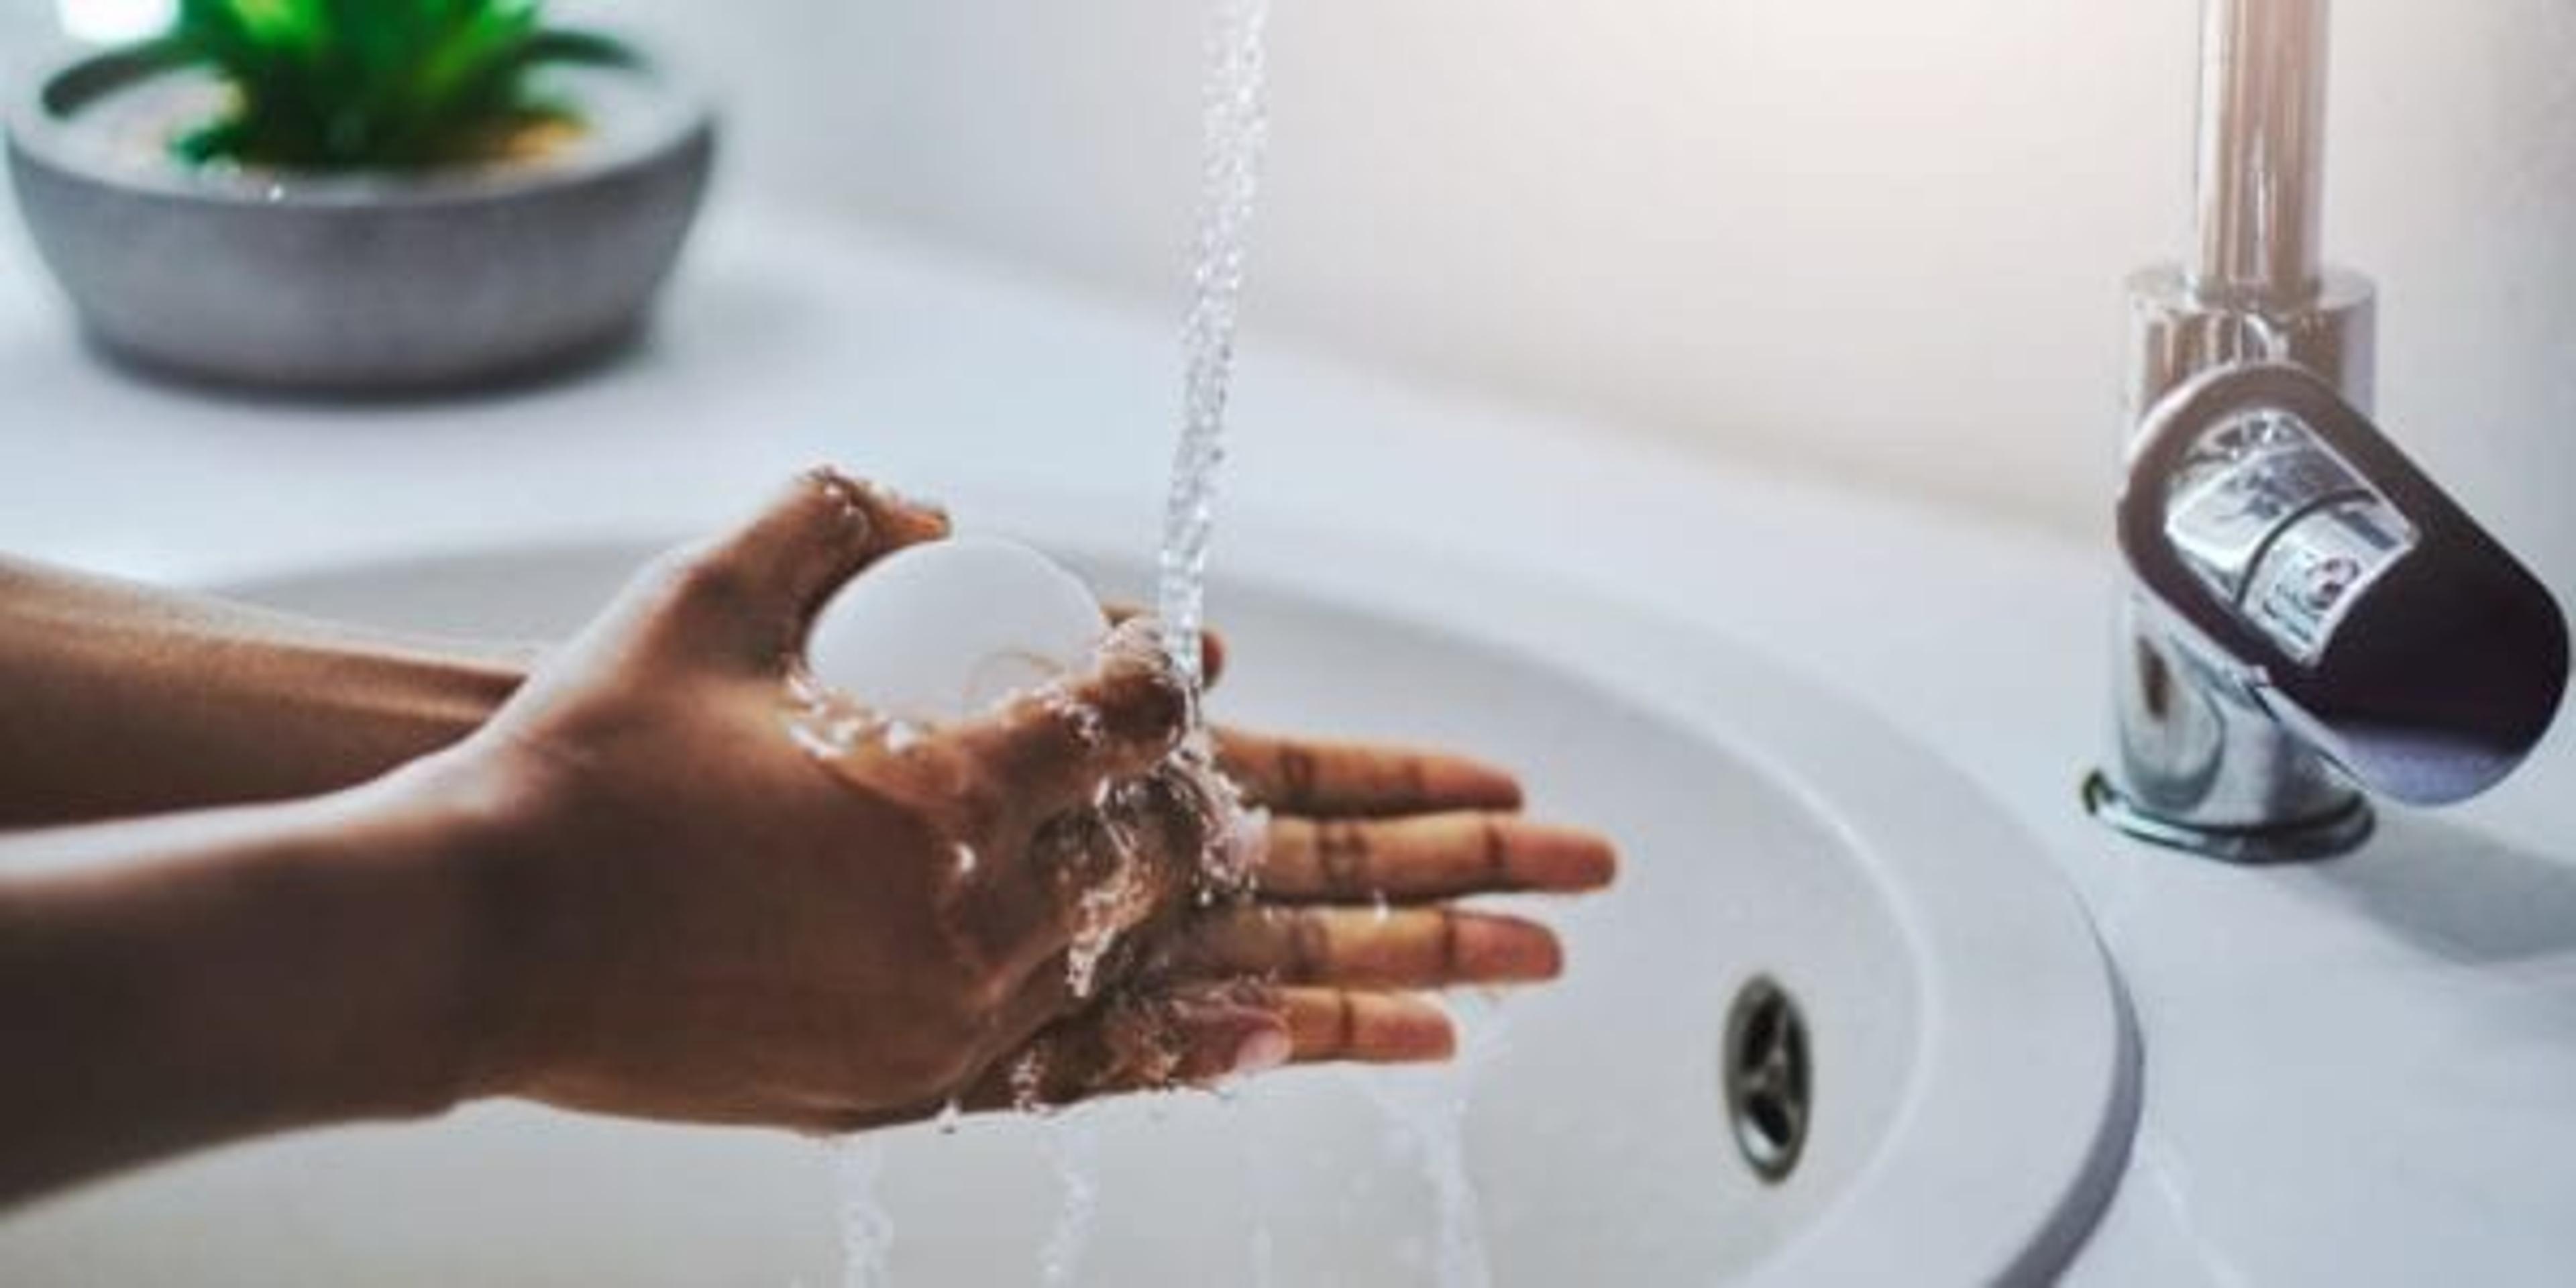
[1216,729,1520,816]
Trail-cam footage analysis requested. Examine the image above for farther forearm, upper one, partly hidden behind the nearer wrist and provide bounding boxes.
[0,561,531,829]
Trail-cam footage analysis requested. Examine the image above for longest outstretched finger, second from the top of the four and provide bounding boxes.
[1254,812,1618,902]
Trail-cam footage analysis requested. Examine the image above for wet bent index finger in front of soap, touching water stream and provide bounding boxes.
[956,626,1193,819]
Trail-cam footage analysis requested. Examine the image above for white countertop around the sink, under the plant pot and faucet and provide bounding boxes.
[0,206,2576,1285]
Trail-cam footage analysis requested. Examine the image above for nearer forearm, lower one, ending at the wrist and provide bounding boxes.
[0,783,476,1205]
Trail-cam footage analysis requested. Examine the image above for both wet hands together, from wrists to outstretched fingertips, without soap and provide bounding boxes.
[407,476,1610,1131]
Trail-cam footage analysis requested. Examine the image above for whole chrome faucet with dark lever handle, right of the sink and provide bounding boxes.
[2084,0,2568,861]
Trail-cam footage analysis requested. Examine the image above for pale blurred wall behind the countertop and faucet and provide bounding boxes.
[0,0,2576,564]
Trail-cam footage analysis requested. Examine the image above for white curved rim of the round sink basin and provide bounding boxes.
[191,502,2141,1283]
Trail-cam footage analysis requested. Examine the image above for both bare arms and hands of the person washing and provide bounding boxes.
[0,474,1613,1200]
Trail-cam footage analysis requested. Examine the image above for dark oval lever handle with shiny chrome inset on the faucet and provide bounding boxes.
[2117,363,2568,804]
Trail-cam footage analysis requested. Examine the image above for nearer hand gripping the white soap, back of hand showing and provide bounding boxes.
[405,476,1267,1131]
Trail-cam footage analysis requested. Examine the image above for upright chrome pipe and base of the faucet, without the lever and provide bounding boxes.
[2086,0,2377,861]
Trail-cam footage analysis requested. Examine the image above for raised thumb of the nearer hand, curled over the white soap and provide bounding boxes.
[672,466,948,665]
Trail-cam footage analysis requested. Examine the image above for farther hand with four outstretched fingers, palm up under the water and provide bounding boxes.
[922,621,1618,1108]
